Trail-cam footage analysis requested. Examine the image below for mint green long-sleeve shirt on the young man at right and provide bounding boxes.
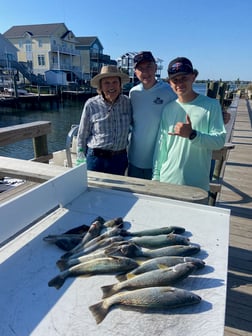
[153,95,226,191]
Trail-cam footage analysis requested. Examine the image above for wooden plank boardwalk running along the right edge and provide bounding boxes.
[217,99,252,336]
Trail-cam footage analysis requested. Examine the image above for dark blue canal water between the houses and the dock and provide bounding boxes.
[0,83,206,160]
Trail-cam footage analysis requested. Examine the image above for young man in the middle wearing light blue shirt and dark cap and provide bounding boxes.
[128,51,177,180]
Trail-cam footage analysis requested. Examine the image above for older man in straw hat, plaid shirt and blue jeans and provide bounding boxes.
[77,65,132,175]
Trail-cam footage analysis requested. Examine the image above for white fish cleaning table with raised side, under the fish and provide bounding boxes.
[0,165,230,336]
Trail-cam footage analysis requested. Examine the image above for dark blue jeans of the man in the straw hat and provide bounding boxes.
[86,148,128,175]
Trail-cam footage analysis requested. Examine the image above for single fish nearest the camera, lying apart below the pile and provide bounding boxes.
[89,286,201,324]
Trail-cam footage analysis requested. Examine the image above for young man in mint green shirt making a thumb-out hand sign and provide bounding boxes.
[153,57,226,191]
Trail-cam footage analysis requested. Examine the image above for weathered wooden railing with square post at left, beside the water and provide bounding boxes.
[0,121,52,163]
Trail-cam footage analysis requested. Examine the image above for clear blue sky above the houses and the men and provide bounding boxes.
[0,0,252,81]
